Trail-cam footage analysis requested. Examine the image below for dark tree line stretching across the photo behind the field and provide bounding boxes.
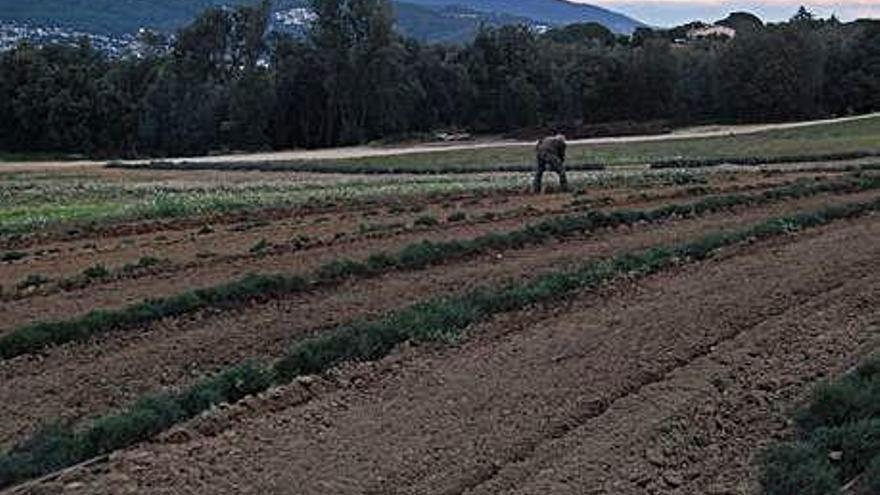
[0,0,880,157]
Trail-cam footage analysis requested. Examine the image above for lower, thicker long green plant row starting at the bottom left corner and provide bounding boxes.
[0,199,880,488]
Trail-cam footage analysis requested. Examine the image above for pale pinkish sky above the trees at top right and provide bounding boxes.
[574,0,880,26]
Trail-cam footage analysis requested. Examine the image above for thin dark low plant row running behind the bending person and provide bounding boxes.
[107,161,606,175]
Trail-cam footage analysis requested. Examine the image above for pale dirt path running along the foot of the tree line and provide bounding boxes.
[0,113,880,172]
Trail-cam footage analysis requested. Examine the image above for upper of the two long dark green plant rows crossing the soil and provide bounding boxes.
[0,176,880,359]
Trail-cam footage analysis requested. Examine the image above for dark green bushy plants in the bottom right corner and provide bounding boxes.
[759,357,880,495]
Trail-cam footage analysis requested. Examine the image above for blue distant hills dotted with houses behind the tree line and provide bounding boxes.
[0,0,641,42]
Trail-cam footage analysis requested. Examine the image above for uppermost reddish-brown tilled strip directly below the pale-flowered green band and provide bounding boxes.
[0,186,571,286]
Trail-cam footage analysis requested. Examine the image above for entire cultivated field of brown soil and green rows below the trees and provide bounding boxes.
[0,118,880,495]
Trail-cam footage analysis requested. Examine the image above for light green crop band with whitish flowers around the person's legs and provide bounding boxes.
[0,171,720,242]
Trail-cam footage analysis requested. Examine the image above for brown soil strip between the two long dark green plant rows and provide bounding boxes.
[0,186,876,454]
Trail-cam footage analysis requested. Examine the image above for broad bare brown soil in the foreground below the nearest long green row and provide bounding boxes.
[20,201,880,494]
